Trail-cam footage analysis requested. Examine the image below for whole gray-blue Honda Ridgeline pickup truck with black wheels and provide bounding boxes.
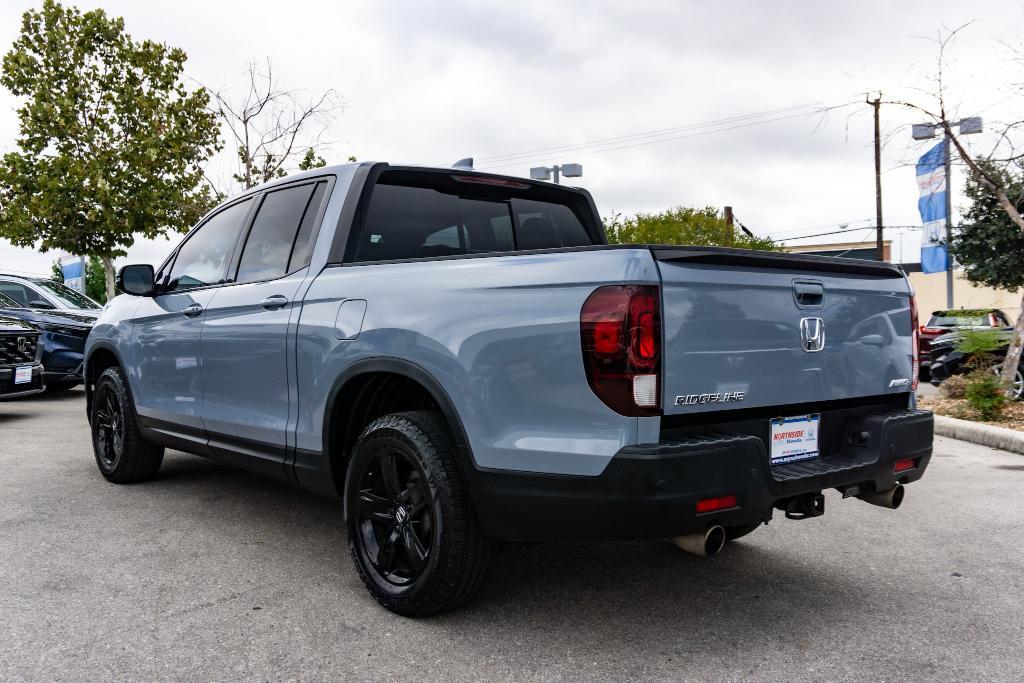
[85,163,932,615]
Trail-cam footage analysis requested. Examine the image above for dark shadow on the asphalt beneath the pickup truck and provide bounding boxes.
[145,454,864,661]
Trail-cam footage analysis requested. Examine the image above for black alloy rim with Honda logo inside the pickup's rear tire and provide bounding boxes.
[357,446,436,586]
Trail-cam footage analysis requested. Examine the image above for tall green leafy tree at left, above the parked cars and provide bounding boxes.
[0,0,219,295]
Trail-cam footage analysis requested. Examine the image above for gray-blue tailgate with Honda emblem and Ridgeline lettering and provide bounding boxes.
[652,248,912,415]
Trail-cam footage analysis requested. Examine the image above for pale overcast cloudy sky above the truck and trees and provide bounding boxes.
[0,0,1024,273]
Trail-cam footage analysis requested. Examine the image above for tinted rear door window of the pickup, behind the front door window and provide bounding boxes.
[236,182,327,283]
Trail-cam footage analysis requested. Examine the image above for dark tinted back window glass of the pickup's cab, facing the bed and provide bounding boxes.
[352,176,594,261]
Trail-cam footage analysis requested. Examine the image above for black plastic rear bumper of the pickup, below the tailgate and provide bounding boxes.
[473,410,933,540]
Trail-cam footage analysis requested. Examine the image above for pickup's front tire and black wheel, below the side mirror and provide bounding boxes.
[89,366,164,483]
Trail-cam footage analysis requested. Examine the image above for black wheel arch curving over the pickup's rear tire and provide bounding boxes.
[323,358,473,496]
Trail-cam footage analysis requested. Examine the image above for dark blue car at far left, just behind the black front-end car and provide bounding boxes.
[0,290,98,391]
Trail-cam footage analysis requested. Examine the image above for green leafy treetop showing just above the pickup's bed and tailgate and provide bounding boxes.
[604,207,778,251]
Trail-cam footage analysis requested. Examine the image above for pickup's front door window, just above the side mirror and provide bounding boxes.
[167,200,251,292]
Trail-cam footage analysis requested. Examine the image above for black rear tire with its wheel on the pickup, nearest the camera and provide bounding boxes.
[344,412,498,616]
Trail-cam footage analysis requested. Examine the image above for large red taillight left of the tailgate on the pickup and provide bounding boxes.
[580,285,662,416]
